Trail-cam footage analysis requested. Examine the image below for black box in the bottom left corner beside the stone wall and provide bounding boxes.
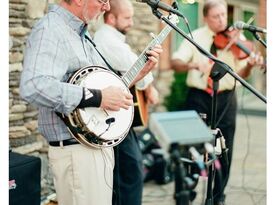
[9,152,41,205]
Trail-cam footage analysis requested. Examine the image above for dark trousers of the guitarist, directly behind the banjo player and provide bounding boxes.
[113,129,143,205]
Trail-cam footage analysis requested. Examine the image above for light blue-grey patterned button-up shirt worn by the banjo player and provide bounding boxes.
[20,5,105,141]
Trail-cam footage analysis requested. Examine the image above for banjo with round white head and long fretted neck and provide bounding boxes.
[58,15,178,148]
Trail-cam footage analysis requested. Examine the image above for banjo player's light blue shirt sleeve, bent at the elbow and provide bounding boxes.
[20,27,82,114]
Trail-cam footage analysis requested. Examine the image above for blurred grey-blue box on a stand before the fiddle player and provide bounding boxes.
[149,110,214,152]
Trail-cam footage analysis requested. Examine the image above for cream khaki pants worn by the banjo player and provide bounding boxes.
[49,144,114,205]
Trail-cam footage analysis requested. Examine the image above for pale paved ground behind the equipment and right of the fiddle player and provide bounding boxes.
[143,93,266,205]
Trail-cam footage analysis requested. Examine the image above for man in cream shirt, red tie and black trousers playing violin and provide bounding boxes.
[171,0,263,205]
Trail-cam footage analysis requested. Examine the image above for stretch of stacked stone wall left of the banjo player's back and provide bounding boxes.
[9,0,53,199]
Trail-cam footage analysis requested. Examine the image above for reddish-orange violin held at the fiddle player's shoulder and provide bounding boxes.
[214,26,254,60]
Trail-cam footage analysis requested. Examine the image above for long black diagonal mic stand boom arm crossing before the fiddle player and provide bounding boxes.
[152,8,266,103]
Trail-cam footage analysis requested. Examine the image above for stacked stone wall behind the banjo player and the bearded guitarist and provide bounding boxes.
[9,0,164,199]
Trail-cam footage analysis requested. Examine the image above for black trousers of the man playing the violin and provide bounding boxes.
[184,88,237,202]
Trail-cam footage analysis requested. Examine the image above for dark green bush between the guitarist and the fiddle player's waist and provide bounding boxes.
[164,72,188,111]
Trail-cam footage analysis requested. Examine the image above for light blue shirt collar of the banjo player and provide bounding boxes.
[49,4,87,35]
